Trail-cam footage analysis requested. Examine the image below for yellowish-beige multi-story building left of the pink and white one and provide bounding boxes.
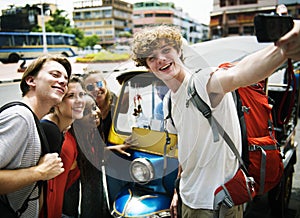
[73,0,133,47]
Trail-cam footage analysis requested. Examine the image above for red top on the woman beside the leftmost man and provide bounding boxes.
[40,132,80,218]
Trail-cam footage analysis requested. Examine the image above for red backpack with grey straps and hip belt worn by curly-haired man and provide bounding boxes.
[180,63,284,209]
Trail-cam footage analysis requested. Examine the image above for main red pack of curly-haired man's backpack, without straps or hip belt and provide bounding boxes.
[237,83,284,194]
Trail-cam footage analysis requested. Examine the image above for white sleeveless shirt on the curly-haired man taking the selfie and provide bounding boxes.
[168,68,242,209]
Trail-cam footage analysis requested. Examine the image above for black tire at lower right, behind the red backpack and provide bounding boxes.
[268,164,294,218]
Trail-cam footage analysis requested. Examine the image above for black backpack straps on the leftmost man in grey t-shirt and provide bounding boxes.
[0,101,50,217]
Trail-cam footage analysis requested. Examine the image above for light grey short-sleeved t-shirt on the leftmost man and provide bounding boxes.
[0,105,41,217]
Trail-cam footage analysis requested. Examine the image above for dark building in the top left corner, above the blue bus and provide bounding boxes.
[1,3,57,32]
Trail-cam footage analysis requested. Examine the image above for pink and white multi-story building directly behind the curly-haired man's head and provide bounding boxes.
[132,0,208,43]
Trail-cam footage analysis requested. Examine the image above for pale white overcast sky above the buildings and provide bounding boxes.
[0,0,213,24]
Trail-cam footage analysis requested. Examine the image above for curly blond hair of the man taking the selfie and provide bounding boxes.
[132,25,182,67]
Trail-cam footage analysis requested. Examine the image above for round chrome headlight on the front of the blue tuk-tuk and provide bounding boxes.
[130,158,154,184]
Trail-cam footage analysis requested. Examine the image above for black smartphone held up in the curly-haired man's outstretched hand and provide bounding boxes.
[254,14,294,42]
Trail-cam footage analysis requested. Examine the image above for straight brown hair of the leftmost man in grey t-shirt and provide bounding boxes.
[20,55,72,97]
